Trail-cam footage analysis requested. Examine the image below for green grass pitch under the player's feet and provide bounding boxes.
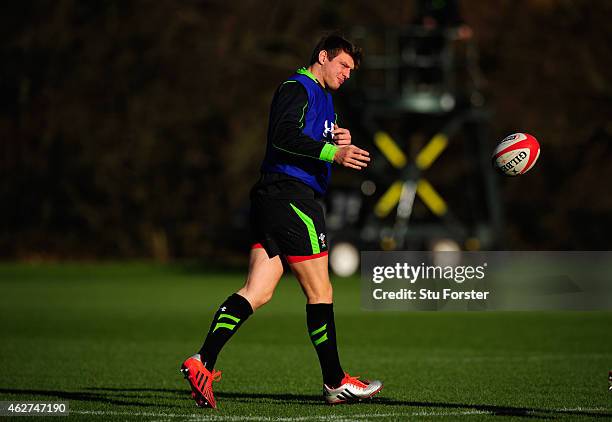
[0,264,612,421]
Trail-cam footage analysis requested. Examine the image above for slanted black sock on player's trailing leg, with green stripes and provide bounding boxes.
[199,293,253,371]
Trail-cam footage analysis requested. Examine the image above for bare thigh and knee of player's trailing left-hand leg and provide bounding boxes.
[238,248,283,310]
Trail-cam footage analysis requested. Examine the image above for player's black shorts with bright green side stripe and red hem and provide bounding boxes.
[250,192,327,263]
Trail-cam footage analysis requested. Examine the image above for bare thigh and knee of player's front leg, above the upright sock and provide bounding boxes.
[289,255,333,304]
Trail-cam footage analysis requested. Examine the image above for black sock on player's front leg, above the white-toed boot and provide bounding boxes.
[306,303,344,387]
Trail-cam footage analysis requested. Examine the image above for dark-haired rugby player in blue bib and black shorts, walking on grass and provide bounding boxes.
[181,35,382,408]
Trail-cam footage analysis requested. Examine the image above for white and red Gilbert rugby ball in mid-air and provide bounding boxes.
[493,133,540,176]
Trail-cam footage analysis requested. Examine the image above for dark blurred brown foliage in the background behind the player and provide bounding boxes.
[0,0,612,260]
